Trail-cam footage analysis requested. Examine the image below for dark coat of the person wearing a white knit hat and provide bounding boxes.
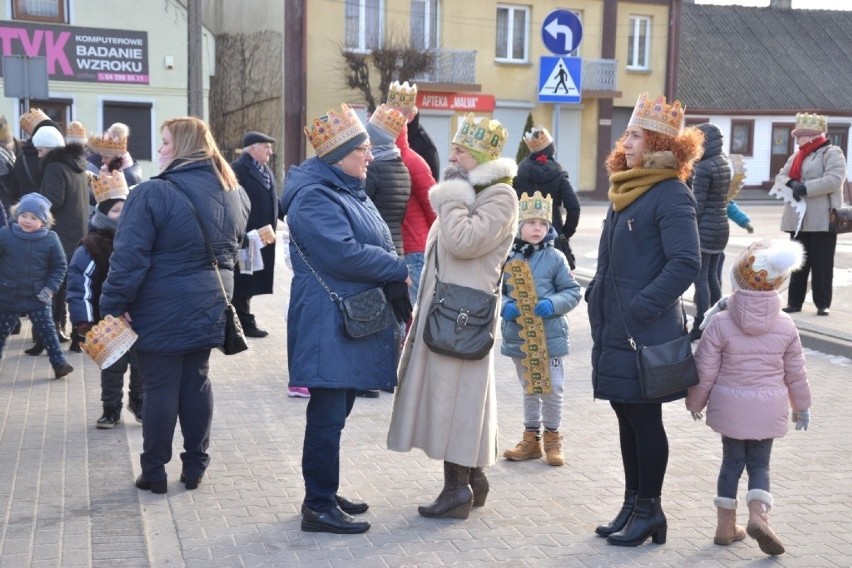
[39,144,89,260]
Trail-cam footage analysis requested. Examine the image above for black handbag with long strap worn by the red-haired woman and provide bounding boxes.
[609,211,699,399]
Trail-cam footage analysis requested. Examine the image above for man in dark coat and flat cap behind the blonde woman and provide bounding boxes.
[231,132,278,337]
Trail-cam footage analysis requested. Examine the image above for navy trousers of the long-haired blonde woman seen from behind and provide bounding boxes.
[136,349,213,481]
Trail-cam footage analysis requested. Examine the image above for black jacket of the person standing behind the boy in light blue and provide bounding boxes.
[512,144,580,239]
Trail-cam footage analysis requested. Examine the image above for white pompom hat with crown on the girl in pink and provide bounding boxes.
[731,240,805,292]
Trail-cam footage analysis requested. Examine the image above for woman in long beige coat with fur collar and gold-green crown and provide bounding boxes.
[388,114,518,519]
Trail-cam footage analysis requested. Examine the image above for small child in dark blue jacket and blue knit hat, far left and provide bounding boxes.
[0,193,74,379]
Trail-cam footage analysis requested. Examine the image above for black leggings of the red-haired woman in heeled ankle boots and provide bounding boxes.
[610,402,669,499]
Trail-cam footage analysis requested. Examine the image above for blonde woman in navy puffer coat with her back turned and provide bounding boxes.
[100,117,250,493]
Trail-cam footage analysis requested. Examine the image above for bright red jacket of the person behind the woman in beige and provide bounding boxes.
[396,127,436,254]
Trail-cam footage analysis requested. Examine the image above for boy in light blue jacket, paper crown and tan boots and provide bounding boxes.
[500,192,580,466]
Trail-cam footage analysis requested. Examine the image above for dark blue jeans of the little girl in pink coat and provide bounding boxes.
[716,436,772,499]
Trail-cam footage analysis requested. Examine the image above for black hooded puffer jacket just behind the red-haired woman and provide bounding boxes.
[692,126,731,254]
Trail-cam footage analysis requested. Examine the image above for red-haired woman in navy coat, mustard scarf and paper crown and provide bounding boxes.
[586,94,704,546]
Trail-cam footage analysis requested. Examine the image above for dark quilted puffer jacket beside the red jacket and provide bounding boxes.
[364,156,411,256]
